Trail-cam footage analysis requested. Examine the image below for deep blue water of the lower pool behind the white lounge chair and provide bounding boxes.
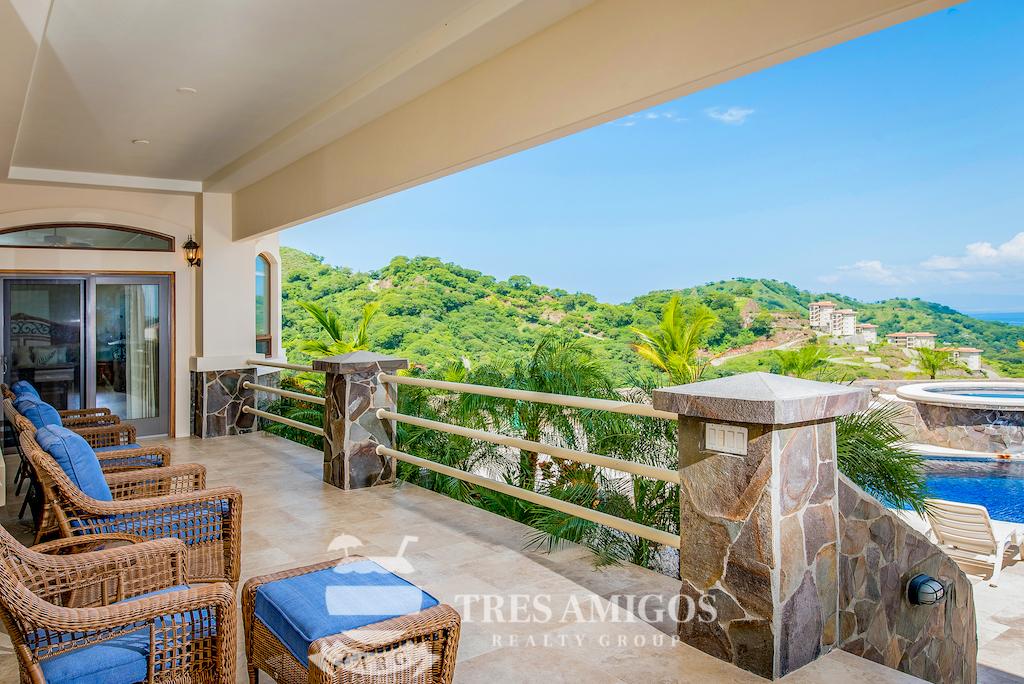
[925,456,1024,522]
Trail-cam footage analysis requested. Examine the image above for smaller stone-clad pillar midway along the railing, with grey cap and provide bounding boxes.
[312,351,409,489]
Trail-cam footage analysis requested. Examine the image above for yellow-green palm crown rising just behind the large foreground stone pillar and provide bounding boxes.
[630,295,718,385]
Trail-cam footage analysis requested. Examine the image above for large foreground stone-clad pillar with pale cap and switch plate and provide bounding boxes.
[654,373,868,679]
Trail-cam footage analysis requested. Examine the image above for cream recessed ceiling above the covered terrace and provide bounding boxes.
[0,0,589,191]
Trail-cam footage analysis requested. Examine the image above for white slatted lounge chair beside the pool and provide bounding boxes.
[926,499,1024,587]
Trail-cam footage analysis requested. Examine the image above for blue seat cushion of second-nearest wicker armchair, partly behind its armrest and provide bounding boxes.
[82,501,229,545]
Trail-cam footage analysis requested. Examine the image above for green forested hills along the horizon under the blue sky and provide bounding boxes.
[281,247,1024,380]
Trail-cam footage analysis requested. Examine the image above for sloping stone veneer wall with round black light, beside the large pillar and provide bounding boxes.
[839,474,978,684]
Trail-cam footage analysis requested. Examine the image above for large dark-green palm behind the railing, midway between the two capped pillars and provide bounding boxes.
[454,335,614,489]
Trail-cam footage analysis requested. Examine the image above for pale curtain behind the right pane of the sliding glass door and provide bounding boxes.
[124,285,160,419]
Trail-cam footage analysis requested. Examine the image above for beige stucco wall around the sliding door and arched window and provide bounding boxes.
[0,182,281,437]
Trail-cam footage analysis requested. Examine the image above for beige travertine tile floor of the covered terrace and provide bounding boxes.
[0,433,1024,684]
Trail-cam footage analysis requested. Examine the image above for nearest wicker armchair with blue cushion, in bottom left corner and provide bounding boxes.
[0,527,237,684]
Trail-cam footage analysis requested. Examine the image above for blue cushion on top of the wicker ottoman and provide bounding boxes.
[255,560,437,667]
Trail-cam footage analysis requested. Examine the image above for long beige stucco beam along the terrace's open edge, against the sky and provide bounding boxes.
[233,0,955,238]
